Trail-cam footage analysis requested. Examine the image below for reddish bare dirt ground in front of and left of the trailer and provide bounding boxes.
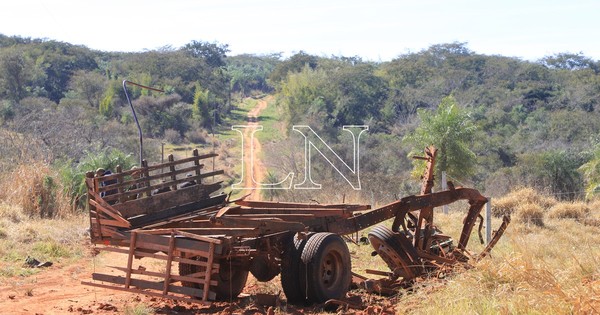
[0,245,396,314]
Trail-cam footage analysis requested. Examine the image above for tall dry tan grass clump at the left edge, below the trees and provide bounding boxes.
[0,162,71,218]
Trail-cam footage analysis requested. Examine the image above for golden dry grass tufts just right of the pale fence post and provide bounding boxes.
[492,187,557,217]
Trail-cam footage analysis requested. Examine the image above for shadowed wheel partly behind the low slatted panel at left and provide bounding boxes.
[179,259,248,300]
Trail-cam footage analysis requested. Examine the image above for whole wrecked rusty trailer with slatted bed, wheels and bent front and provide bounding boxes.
[85,148,508,304]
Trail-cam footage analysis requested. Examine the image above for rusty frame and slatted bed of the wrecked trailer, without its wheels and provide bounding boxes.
[86,147,510,302]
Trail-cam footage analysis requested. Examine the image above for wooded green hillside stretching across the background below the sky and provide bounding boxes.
[0,35,600,212]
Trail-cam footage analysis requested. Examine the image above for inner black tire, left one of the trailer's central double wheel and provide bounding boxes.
[281,233,314,305]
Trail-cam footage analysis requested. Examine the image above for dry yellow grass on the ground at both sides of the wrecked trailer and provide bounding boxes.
[0,175,600,314]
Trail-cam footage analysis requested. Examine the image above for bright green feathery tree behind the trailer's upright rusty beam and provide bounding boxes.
[403,95,476,179]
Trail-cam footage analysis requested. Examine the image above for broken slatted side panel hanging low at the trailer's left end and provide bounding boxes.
[82,230,222,304]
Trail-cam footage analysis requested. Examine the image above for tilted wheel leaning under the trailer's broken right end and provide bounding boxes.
[368,226,419,280]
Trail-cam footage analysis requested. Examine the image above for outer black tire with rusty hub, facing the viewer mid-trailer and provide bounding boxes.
[300,233,352,303]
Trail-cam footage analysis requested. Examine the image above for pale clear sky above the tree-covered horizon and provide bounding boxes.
[0,0,600,61]
